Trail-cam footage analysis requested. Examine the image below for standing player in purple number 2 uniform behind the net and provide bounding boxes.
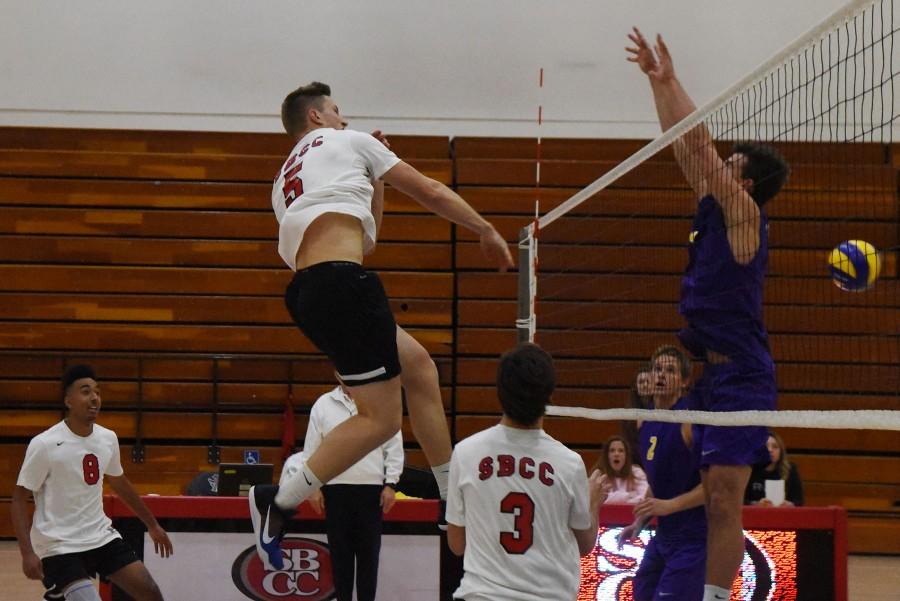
[620,346,706,601]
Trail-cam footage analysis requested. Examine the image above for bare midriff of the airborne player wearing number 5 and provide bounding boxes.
[296,213,363,269]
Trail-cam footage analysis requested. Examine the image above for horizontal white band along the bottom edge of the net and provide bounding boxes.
[547,405,900,431]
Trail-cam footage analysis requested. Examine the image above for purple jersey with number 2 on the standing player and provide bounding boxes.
[639,397,706,541]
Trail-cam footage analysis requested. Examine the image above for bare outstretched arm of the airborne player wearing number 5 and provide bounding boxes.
[382,161,514,271]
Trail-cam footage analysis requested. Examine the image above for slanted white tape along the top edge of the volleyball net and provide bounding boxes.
[538,0,873,228]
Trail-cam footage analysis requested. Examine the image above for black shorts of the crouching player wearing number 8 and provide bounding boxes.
[41,538,138,601]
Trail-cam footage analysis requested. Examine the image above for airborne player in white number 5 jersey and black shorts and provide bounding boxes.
[250,82,513,569]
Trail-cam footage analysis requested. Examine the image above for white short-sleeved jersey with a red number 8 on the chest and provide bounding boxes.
[16,421,122,559]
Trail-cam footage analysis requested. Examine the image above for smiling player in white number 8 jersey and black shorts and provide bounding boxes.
[11,365,172,601]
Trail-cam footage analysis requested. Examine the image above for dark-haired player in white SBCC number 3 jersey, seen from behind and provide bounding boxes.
[447,343,609,601]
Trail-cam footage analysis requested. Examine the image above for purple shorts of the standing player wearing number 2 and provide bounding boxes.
[634,536,706,601]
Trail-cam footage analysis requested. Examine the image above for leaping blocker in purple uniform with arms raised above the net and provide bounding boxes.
[627,28,789,601]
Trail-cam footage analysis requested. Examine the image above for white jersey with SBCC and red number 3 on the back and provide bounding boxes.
[447,424,591,601]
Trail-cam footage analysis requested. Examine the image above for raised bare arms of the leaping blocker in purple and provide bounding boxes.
[626,27,759,264]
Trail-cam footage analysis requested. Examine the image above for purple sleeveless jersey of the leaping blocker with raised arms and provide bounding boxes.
[678,195,774,370]
